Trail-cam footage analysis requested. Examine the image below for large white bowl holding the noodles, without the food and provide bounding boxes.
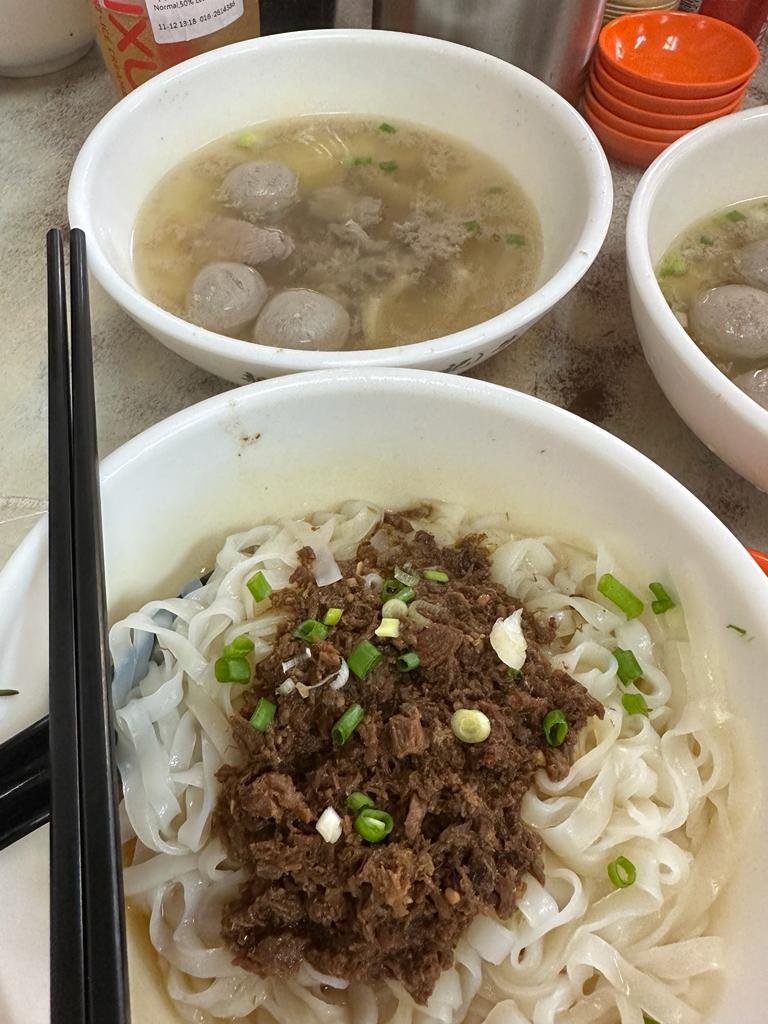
[0,369,768,1024]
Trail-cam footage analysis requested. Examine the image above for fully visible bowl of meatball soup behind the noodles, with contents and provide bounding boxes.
[69,31,612,383]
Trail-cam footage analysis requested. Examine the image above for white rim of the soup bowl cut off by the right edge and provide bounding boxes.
[626,103,768,442]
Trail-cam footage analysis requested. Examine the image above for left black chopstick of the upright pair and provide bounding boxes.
[47,228,86,1024]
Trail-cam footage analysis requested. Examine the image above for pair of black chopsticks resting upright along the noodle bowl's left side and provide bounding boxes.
[47,228,130,1024]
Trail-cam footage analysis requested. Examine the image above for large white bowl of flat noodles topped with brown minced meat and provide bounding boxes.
[0,370,768,1024]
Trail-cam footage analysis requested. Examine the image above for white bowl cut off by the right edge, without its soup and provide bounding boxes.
[627,106,768,490]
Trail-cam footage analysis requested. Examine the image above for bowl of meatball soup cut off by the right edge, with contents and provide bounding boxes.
[627,106,768,490]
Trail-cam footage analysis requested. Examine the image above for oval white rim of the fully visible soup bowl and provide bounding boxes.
[68,29,613,372]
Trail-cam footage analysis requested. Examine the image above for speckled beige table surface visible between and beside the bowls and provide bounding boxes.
[0,12,768,564]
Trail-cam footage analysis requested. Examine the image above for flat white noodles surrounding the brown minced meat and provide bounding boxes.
[110,502,738,1024]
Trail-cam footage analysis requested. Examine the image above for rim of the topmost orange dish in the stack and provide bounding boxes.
[597,10,760,98]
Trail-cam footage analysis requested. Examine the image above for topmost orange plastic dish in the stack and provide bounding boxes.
[598,11,760,97]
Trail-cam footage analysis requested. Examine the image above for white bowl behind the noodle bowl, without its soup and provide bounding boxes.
[69,30,612,383]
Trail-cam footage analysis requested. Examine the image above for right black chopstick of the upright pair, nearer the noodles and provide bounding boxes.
[70,228,130,1024]
